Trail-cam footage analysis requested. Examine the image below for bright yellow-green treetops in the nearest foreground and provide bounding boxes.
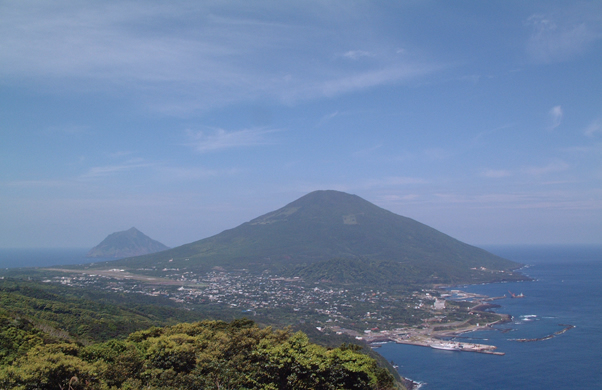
[0,320,404,390]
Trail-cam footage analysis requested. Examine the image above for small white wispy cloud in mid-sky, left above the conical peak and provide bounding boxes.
[187,129,280,153]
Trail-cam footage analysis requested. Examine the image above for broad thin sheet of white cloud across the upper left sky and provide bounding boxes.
[0,0,439,113]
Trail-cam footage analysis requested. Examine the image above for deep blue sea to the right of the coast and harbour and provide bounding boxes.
[377,246,602,390]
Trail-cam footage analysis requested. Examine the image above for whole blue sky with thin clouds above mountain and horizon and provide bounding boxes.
[0,0,602,248]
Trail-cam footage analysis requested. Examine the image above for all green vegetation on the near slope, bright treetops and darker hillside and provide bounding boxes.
[0,279,402,390]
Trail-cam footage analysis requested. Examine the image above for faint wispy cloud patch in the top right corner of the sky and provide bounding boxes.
[525,7,602,63]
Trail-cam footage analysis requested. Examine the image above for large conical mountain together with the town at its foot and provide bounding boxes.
[57,190,530,352]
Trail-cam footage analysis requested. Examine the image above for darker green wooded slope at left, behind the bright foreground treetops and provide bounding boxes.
[0,279,207,342]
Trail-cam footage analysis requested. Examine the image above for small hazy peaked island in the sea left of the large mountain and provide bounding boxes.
[86,227,169,259]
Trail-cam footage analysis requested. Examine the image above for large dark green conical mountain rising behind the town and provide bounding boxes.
[99,191,518,282]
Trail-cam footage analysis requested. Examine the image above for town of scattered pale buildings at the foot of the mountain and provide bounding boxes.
[43,267,506,345]
